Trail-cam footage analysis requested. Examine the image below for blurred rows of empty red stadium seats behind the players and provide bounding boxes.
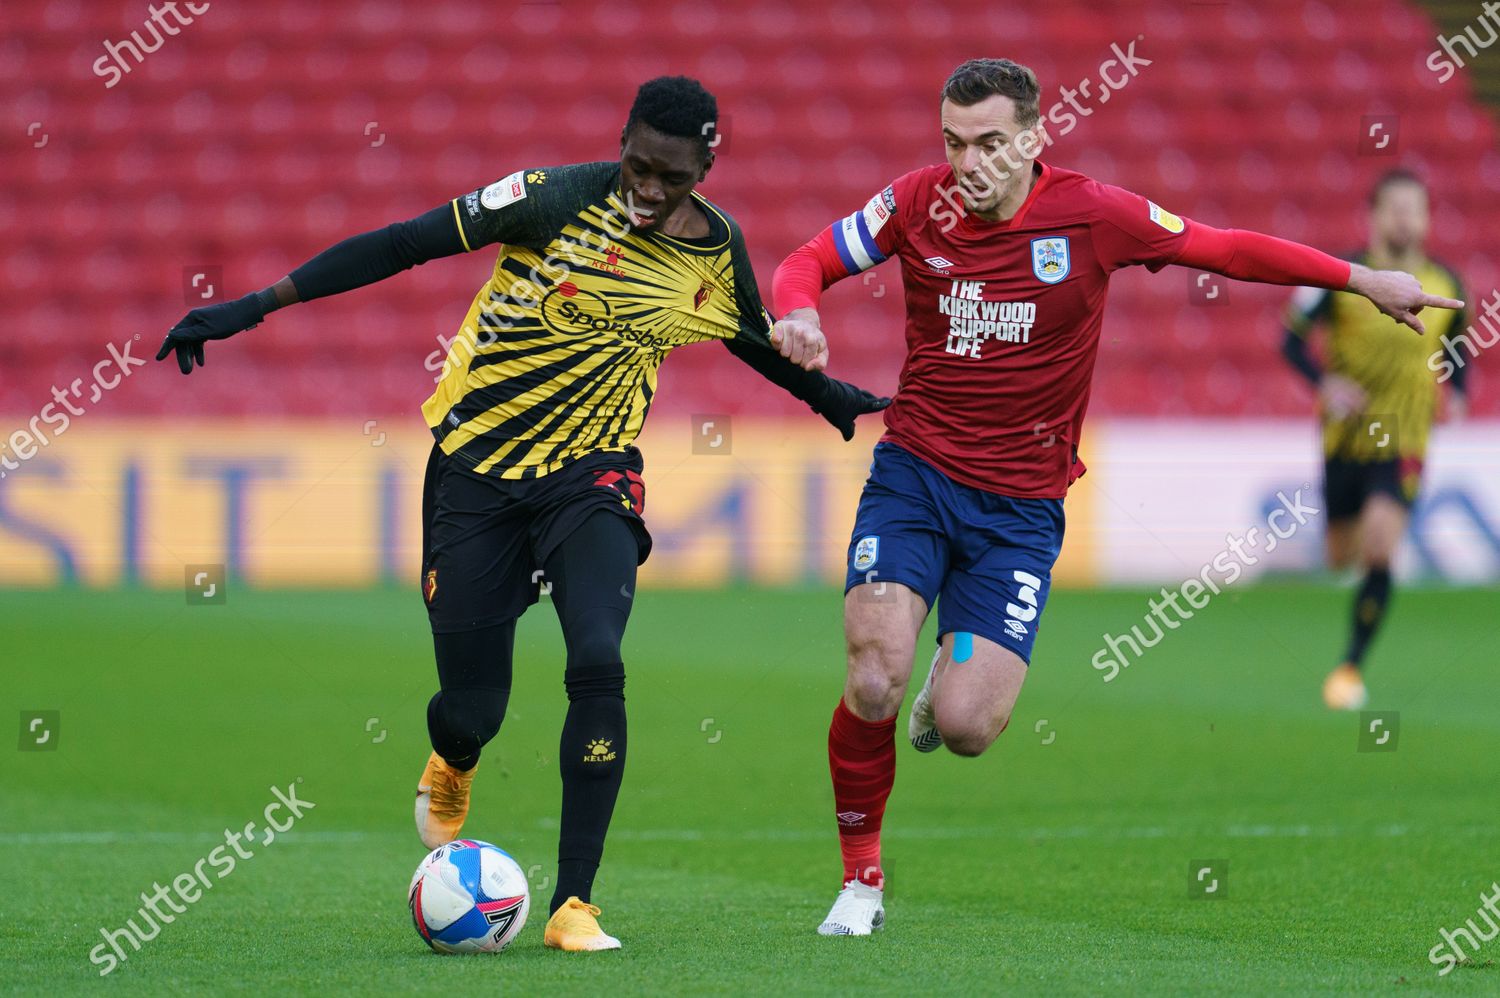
[0,0,1500,419]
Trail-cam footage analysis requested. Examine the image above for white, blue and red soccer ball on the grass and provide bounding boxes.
[407,839,531,953]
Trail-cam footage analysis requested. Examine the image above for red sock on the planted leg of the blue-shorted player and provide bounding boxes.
[828,699,896,887]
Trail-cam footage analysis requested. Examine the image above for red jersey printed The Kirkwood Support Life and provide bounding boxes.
[831,164,1193,498]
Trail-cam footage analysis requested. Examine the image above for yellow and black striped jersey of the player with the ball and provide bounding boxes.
[422,162,771,479]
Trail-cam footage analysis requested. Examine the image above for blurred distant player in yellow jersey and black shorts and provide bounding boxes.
[1283,170,1467,710]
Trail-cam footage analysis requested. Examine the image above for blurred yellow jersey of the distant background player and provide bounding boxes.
[1287,254,1467,461]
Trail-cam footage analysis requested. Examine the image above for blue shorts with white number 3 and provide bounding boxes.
[845,443,1064,663]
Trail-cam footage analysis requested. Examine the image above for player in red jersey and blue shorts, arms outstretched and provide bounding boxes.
[774,59,1463,935]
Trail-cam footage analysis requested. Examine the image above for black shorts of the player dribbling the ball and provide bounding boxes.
[422,447,651,633]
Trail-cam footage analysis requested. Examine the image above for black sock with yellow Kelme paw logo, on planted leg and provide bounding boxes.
[551,663,626,911]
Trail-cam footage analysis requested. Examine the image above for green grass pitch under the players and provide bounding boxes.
[0,584,1500,995]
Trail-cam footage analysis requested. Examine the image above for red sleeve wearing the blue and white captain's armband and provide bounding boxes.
[771,177,905,315]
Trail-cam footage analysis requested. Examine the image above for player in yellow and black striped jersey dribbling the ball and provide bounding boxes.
[158,77,890,950]
